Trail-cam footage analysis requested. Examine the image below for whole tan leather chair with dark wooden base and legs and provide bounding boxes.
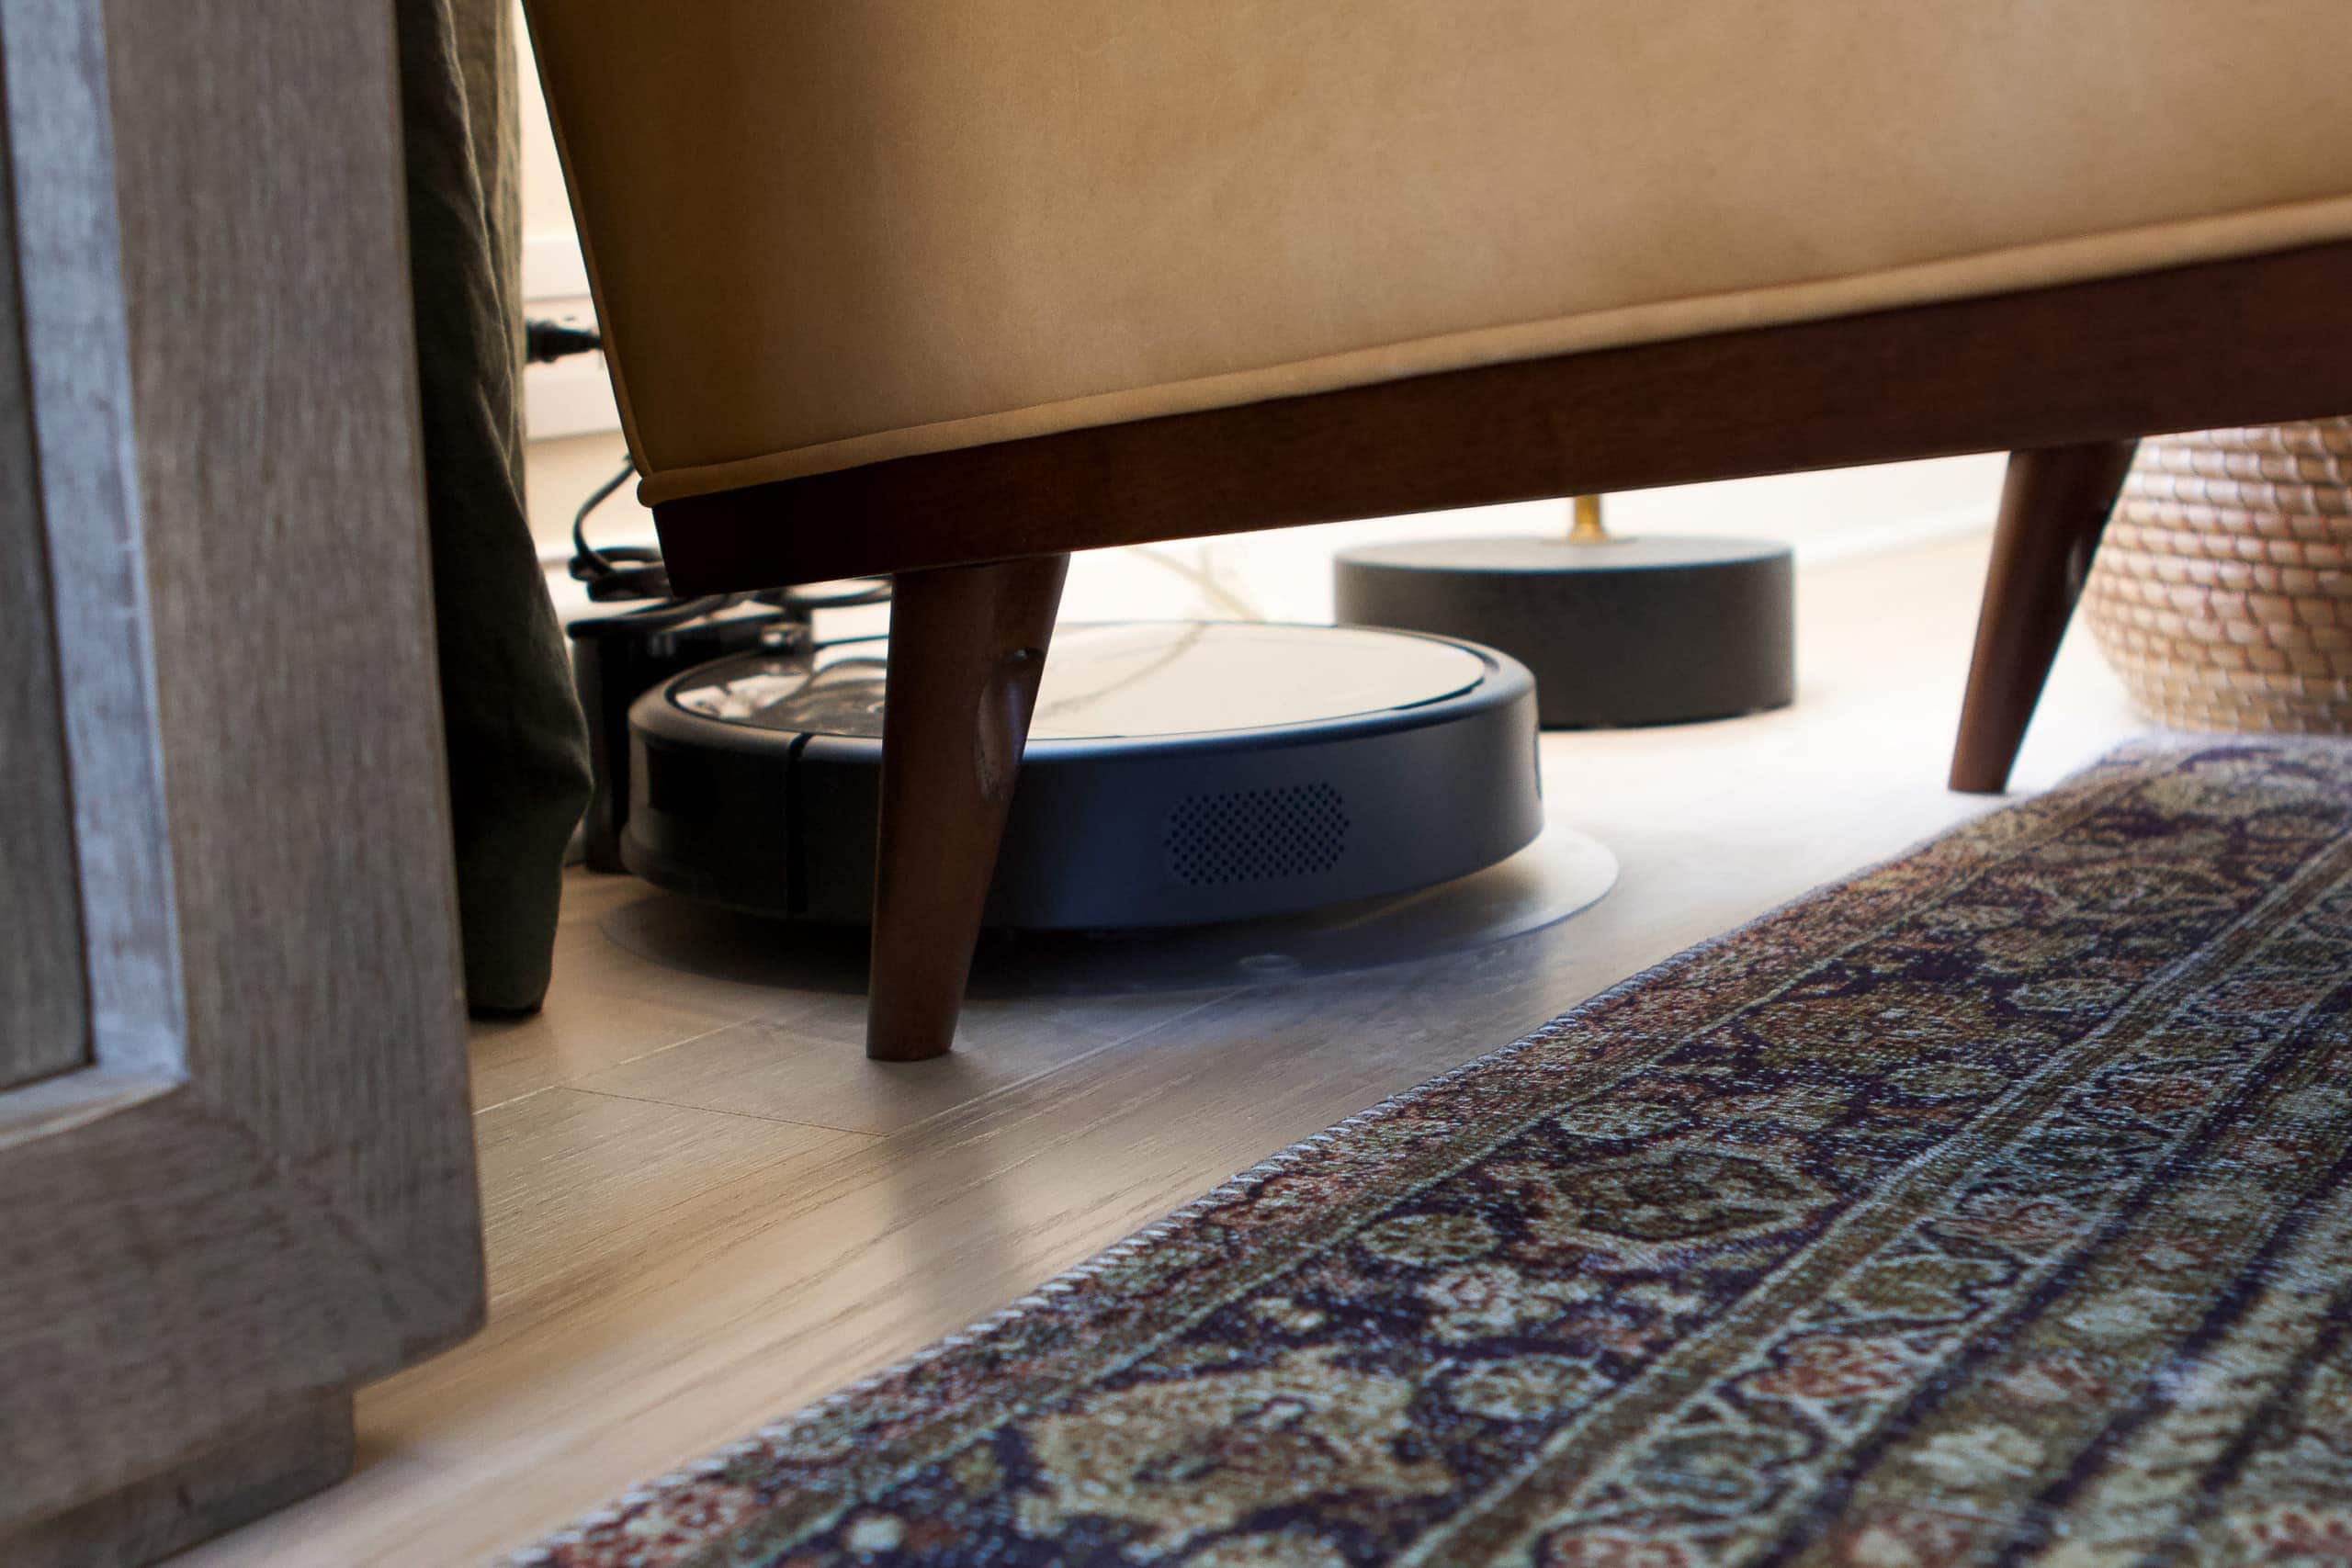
[529,0,2352,1058]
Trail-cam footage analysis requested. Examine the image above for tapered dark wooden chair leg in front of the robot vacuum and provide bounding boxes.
[865,555,1070,1063]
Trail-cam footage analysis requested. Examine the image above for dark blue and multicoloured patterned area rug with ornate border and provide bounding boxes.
[517,743,2352,1568]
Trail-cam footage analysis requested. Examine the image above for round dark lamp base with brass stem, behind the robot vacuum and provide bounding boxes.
[1334,536,1797,728]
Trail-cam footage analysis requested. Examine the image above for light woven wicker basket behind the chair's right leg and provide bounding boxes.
[2082,419,2352,733]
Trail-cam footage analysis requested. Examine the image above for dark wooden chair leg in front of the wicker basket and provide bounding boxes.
[1952,442,2138,795]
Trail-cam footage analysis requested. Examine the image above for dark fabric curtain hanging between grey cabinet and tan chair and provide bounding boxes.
[393,0,588,1013]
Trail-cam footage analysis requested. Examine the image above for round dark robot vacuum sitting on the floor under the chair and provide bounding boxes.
[618,621,1543,931]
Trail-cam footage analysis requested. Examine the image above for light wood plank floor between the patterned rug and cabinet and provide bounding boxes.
[186,538,2138,1565]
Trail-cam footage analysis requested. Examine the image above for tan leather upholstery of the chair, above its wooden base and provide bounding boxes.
[526,0,2352,503]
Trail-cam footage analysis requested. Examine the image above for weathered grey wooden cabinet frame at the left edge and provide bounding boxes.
[0,0,482,1563]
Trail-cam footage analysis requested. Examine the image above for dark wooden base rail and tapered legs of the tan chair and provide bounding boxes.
[654,243,2352,1060]
